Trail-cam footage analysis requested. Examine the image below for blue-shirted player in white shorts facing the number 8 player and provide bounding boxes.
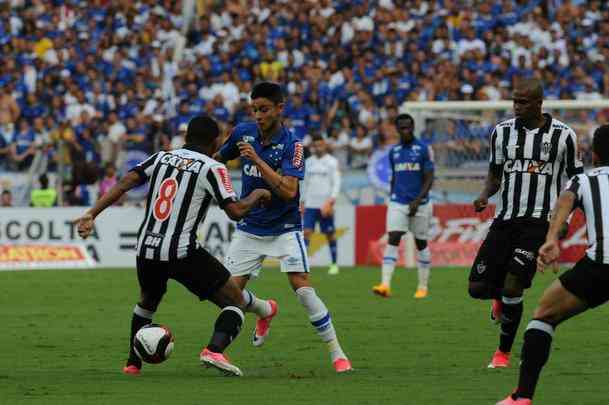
[214,82,351,373]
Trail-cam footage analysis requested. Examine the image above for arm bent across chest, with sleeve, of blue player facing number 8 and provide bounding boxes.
[238,142,304,201]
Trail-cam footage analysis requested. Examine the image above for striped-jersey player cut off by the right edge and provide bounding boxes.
[498,125,609,405]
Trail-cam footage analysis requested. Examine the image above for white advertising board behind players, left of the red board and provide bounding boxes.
[0,205,355,267]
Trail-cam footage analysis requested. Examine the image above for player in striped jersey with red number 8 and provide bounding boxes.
[76,116,271,375]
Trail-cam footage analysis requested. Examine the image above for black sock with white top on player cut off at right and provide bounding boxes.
[514,320,554,399]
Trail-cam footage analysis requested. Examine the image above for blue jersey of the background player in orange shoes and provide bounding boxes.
[389,139,434,204]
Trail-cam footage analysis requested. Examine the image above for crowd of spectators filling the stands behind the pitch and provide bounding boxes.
[0,0,609,202]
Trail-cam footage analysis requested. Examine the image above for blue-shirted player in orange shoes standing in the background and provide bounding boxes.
[372,114,434,298]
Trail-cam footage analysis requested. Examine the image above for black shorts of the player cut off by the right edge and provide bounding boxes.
[559,256,609,308]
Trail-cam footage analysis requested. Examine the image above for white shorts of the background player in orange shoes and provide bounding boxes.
[387,201,432,240]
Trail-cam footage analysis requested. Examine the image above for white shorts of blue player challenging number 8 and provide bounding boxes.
[224,230,309,277]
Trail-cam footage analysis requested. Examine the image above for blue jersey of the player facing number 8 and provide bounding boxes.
[220,122,305,236]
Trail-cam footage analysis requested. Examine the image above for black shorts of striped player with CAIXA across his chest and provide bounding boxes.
[469,218,549,288]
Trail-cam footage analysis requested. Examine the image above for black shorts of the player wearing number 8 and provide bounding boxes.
[137,248,230,301]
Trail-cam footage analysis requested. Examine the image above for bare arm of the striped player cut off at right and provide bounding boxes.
[537,176,581,272]
